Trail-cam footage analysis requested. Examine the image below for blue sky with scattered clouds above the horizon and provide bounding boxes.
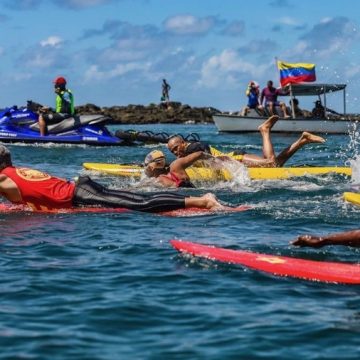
[0,0,360,112]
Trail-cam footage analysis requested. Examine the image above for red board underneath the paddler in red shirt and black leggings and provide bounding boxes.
[0,203,251,217]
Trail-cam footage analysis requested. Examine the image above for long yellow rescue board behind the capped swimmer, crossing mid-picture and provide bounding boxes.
[83,163,351,181]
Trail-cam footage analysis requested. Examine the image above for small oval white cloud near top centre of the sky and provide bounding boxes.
[164,15,215,35]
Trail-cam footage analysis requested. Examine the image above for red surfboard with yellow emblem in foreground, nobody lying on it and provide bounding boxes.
[170,240,360,284]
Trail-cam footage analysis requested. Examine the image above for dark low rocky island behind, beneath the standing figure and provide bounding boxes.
[76,101,221,124]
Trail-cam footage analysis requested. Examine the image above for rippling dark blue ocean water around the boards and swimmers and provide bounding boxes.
[0,125,360,359]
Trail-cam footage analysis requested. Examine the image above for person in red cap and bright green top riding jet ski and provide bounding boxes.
[39,76,75,136]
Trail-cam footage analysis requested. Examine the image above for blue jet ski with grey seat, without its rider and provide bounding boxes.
[0,101,127,146]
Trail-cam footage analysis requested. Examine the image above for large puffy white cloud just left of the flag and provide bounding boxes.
[198,50,268,88]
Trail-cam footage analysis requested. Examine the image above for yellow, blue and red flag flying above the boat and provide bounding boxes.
[277,61,316,86]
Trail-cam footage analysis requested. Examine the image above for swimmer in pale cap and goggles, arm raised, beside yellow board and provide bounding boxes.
[144,150,212,188]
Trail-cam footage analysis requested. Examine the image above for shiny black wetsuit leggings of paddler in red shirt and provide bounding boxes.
[73,176,185,212]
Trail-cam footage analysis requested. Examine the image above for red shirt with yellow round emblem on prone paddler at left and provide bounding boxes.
[1,166,75,210]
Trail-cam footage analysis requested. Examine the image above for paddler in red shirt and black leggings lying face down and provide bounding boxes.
[0,145,228,212]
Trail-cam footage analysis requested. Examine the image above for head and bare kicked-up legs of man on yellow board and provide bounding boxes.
[168,115,325,167]
